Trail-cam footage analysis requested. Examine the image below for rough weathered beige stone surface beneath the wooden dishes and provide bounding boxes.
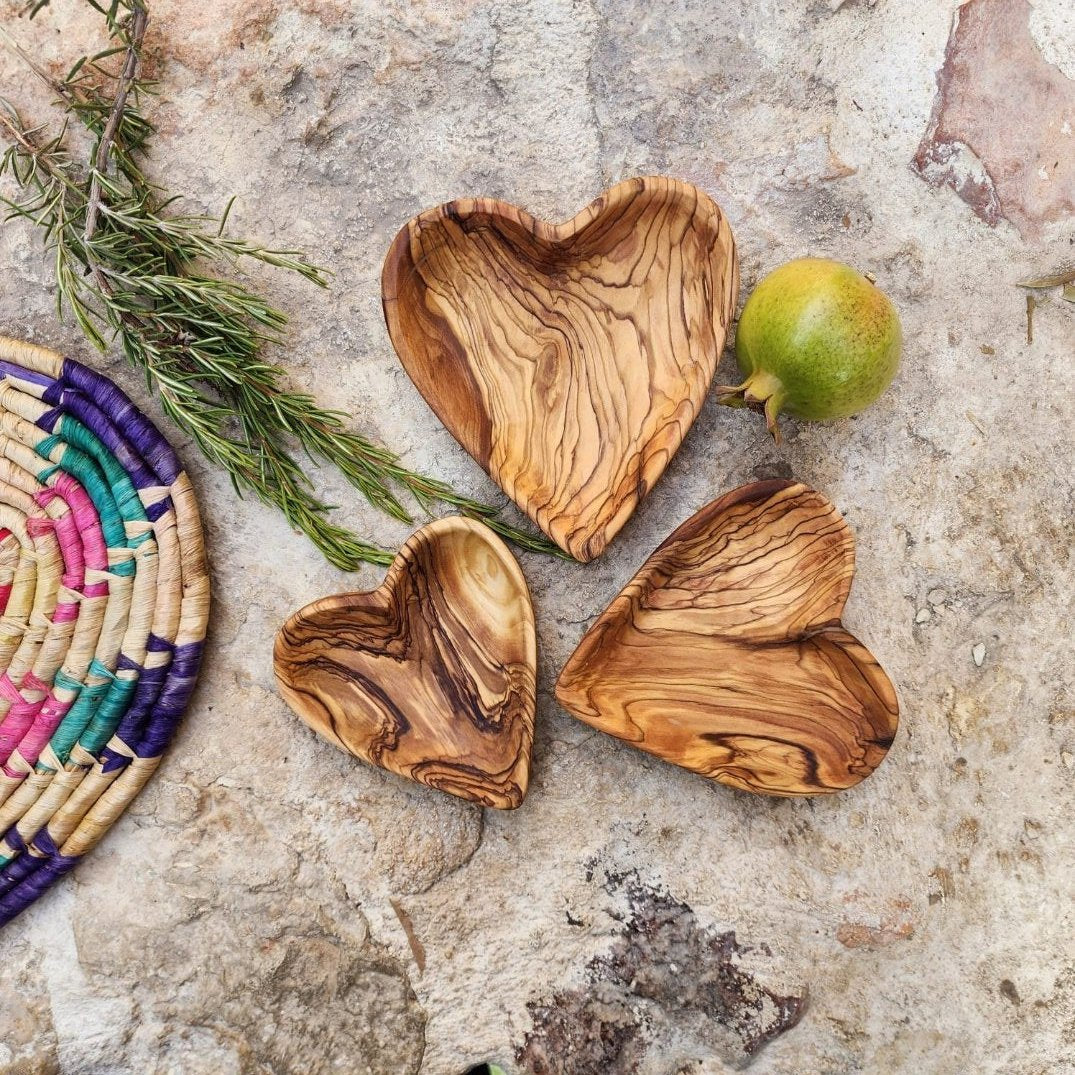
[0,0,1075,1075]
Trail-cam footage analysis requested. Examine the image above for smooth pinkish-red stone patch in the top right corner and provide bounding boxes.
[912,0,1075,238]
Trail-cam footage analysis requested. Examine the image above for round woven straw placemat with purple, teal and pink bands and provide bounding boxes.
[0,336,209,925]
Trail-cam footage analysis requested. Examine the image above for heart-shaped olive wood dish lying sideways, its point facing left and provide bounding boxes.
[556,482,899,796]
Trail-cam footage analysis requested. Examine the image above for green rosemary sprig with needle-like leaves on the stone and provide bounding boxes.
[0,0,557,570]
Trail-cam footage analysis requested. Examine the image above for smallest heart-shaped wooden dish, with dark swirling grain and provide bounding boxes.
[273,518,536,809]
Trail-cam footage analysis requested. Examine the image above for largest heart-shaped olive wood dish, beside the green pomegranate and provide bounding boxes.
[382,176,739,560]
